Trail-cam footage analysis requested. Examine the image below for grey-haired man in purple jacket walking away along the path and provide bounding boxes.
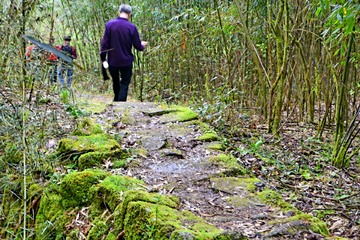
[100,4,147,102]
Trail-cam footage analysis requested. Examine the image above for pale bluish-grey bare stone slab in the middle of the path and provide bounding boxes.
[150,158,211,174]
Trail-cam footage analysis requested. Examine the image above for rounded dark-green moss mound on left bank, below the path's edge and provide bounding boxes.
[60,170,109,208]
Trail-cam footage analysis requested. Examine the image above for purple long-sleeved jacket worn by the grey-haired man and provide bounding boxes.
[100,17,144,67]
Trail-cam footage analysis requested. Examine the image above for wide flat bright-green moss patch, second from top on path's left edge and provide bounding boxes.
[58,134,120,153]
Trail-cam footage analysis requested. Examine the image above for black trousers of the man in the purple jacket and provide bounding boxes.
[109,64,132,102]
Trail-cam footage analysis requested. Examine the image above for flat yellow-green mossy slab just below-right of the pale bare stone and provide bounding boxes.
[210,177,261,194]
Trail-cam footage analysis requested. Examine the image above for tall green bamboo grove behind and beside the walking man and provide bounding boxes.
[0,0,360,167]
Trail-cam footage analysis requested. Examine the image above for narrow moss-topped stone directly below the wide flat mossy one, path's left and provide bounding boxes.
[78,149,130,171]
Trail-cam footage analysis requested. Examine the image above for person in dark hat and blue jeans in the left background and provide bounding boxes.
[58,35,77,88]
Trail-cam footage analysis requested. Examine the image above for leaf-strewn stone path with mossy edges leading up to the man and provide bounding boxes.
[75,96,330,239]
